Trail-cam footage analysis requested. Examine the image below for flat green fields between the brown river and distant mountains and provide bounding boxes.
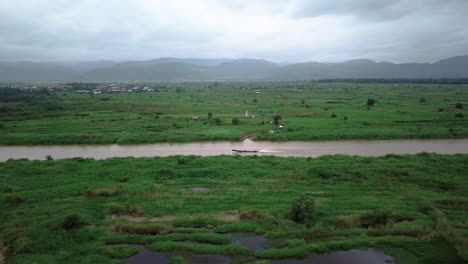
[0,82,468,145]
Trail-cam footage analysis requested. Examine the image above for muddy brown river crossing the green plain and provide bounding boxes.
[0,139,468,161]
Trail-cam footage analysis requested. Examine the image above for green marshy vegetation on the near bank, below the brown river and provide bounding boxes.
[0,153,468,264]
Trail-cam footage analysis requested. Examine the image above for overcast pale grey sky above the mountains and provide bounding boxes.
[0,0,468,63]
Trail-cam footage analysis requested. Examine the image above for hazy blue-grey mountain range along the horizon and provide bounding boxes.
[0,55,468,82]
